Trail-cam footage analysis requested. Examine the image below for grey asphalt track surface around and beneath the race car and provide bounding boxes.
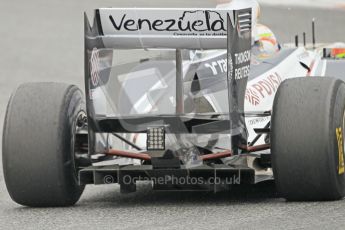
[0,0,345,229]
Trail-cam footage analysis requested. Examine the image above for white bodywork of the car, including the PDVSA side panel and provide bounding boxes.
[131,48,326,148]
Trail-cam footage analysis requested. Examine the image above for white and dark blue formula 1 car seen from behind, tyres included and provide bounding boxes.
[3,4,345,207]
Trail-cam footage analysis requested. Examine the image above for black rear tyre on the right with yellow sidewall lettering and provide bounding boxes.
[271,77,345,201]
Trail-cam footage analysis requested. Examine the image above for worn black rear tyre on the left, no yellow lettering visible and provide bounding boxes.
[2,83,85,207]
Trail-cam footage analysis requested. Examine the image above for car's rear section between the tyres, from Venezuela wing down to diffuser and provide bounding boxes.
[79,8,260,191]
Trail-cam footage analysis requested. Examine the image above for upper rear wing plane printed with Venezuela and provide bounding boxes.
[86,8,252,49]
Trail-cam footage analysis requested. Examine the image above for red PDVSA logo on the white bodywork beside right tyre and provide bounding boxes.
[245,72,282,106]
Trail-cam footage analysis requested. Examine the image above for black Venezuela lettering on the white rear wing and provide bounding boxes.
[109,10,226,36]
